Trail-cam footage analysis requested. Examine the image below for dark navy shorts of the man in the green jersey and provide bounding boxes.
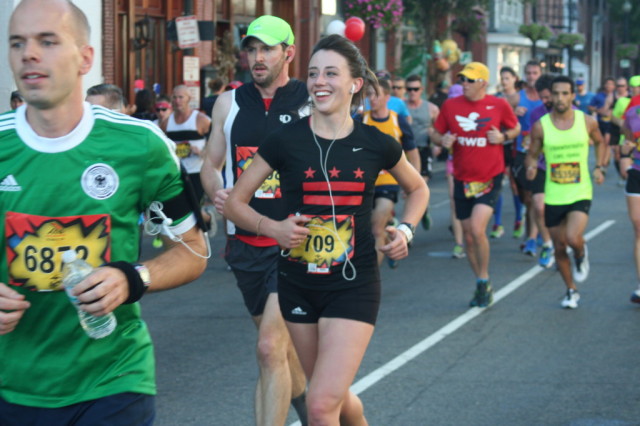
[0,392,156,426]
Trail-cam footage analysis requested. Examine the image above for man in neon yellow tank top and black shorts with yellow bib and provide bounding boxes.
[526,76,606,309]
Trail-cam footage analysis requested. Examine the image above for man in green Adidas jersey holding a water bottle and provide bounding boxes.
[0,0,207,426]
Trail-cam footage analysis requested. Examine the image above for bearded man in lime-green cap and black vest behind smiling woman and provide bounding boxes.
[201,15,309,425]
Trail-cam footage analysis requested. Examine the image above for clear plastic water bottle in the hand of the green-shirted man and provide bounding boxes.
[62,250,117,339]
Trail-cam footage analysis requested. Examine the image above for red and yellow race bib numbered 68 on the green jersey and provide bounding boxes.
[5,212,111,291]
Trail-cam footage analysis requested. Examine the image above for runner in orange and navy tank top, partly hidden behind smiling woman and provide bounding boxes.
[362,80,420,268]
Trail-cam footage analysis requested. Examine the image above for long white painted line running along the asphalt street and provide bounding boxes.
[291,220,616,426]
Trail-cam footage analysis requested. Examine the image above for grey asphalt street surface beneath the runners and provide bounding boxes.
[142,157,640,426]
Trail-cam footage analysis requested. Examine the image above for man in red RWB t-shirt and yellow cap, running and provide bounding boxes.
[434,62,520,308]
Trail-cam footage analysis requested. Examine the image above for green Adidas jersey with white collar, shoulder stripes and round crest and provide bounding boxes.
[0,103,183,408]
